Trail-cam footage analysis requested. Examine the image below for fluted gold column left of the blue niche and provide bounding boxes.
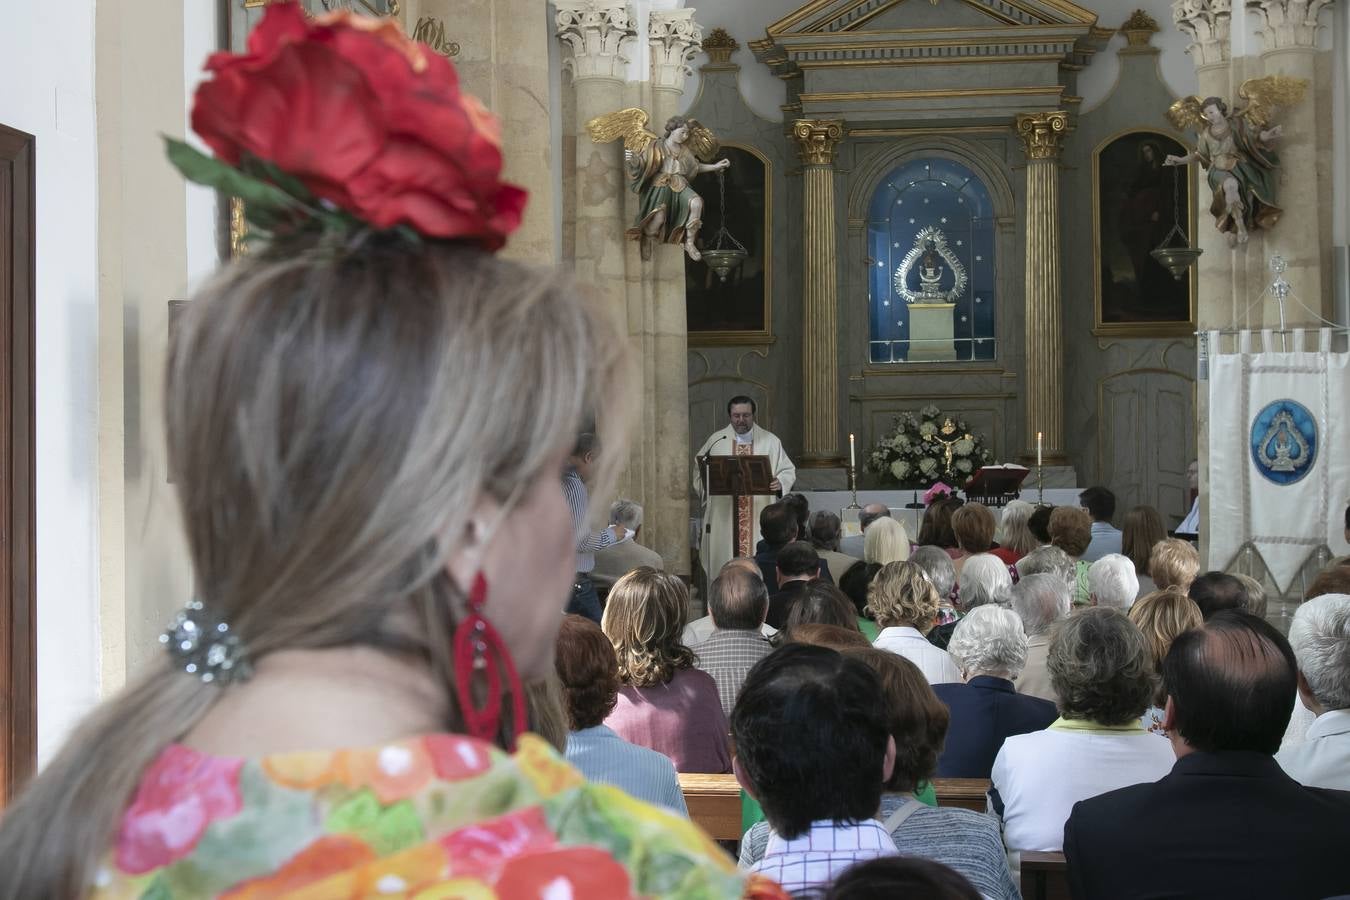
[792,119,844,467]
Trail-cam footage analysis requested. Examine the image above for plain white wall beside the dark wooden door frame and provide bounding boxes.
[0,0,100,760]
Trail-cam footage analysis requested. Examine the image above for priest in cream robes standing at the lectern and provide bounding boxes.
[694,397,797,580]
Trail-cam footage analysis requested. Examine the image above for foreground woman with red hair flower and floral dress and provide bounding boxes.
[0,4,766,900]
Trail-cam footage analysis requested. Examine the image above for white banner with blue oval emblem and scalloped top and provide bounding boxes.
[1204,329,1350,591]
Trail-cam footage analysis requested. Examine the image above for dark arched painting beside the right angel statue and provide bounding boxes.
[1092,131,1195,337]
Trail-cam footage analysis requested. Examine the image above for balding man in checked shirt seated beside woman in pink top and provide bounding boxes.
[690,567,774,715]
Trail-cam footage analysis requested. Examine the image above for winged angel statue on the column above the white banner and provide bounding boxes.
[1164,76,1307,246]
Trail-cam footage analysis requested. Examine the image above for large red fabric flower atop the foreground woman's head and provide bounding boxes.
[192,3,525,250]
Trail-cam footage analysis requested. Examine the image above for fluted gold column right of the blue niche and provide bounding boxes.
[1017,109,1069,466]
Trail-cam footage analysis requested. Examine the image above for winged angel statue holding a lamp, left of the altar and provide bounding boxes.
[586,107,732,260]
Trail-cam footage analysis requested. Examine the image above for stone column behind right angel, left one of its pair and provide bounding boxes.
[1172,0,1236,569]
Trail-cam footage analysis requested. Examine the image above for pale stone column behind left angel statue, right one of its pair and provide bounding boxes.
[645,8,716,575]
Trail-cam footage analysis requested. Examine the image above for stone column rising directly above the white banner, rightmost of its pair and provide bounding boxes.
[1247,0,1331,319]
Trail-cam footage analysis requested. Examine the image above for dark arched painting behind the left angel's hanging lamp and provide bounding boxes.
[684,143,772,345]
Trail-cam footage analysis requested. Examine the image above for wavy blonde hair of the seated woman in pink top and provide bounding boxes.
[601,565,695,688]
